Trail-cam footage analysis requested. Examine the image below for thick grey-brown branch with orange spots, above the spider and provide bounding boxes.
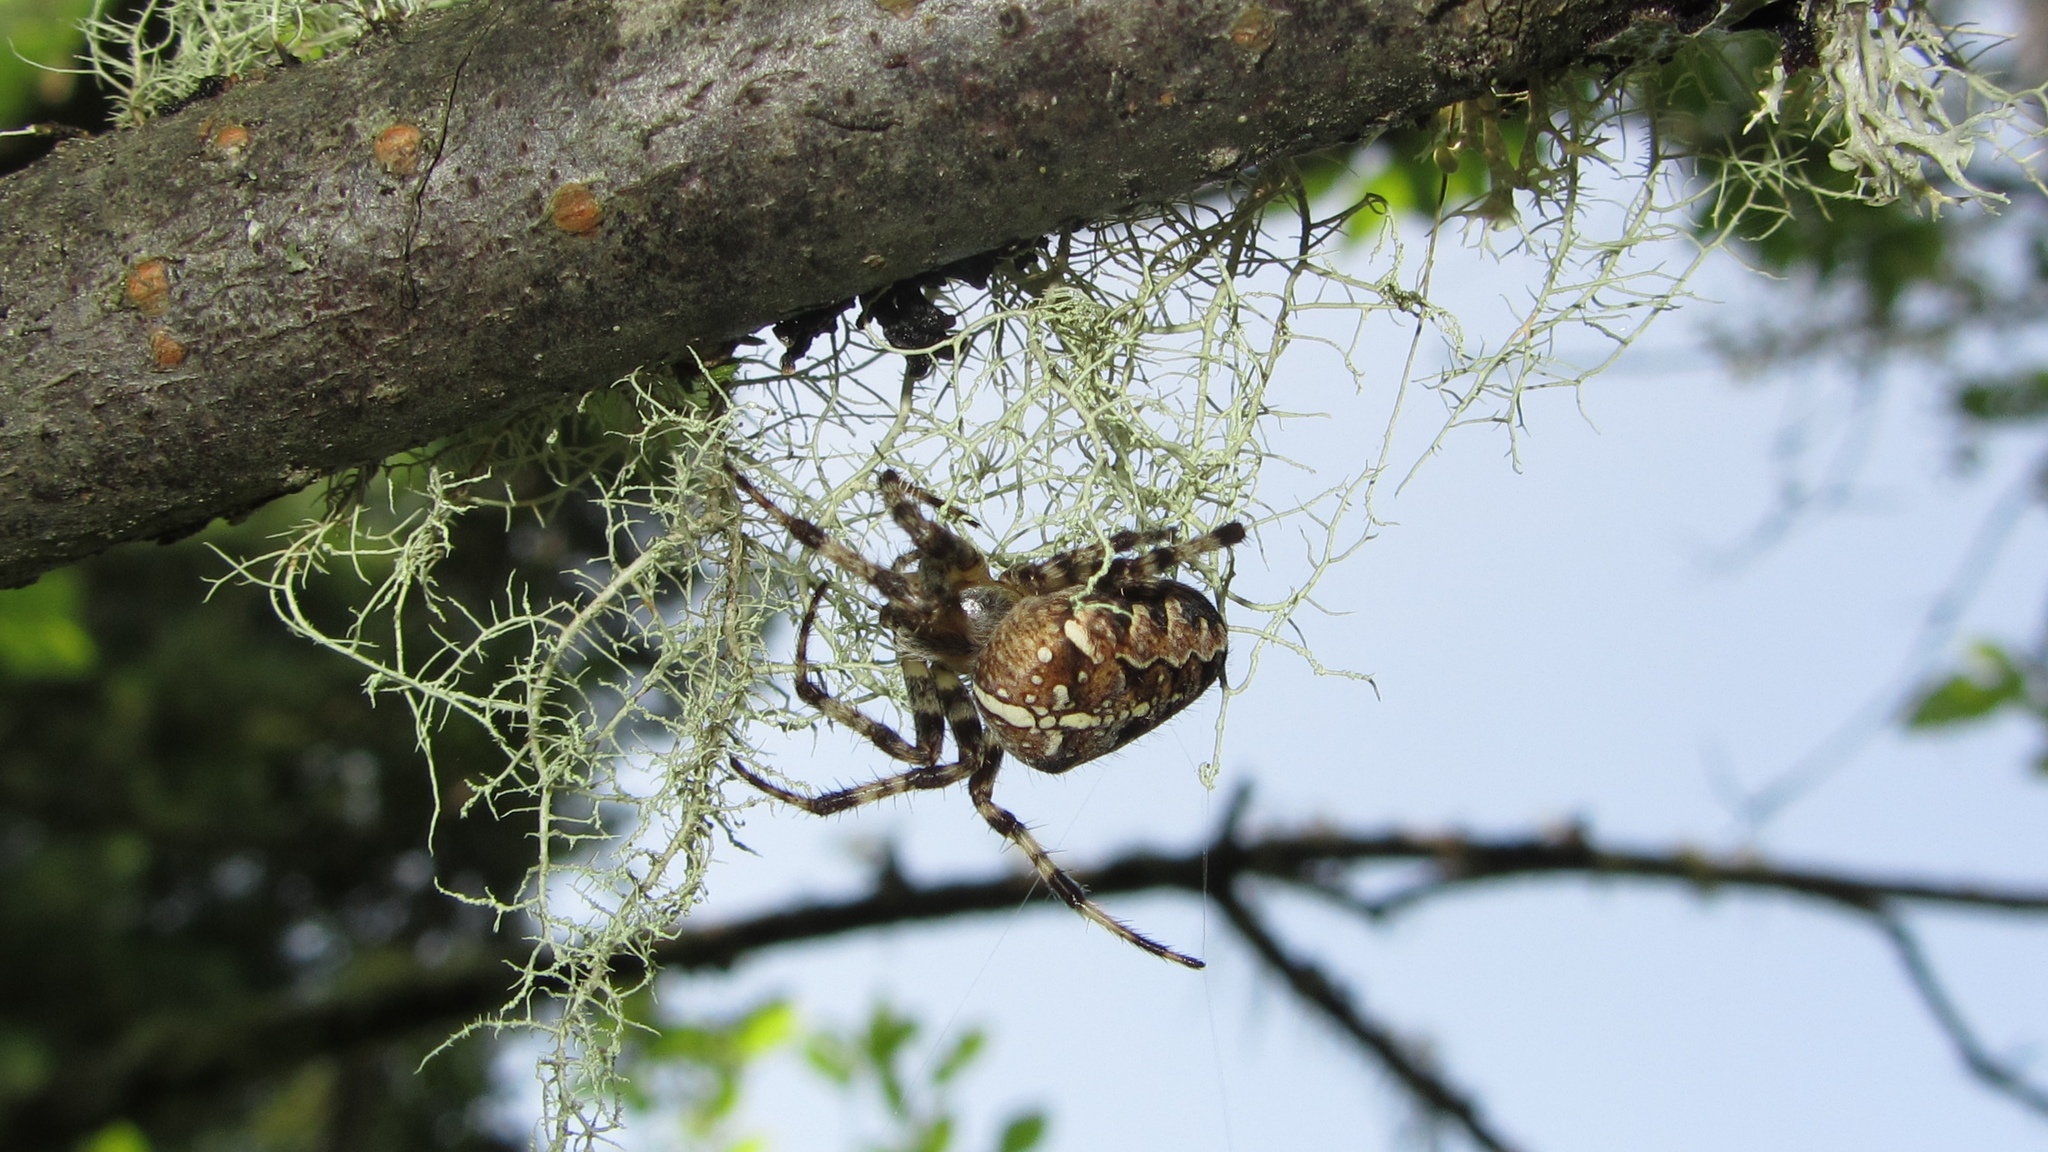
[0,0,1669,586]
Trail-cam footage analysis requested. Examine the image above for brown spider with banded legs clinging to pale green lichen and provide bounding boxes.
[733,471,1245,968]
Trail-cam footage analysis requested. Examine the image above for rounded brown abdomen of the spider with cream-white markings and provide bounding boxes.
[975,580,1229,773]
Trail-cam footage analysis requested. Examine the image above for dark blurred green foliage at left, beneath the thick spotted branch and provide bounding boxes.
[0,496,569,1152]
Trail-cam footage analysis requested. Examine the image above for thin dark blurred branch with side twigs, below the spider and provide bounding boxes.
[19,822,2048,1148]
